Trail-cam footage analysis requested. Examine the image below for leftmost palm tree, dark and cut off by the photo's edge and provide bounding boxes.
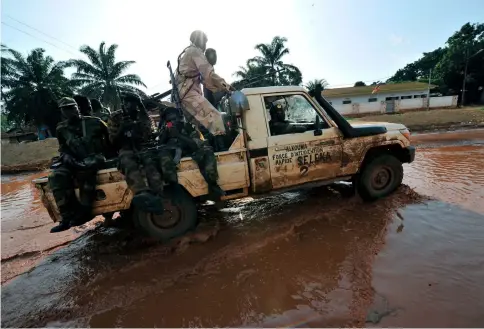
[1,47,73,132]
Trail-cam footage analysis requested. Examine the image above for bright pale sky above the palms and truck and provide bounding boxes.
[1,0,484,94]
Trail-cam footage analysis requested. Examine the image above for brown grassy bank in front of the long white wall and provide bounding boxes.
[352,107,484,132]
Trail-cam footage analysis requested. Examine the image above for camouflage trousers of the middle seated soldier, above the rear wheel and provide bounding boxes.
[119,150,163,196]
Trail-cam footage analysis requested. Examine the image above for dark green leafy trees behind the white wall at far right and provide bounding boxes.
[389,23,484,102]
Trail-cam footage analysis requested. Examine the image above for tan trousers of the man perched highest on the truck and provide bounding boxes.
[182,90,225,136]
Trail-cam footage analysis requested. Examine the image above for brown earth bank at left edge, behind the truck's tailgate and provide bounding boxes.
[1,138,59,173]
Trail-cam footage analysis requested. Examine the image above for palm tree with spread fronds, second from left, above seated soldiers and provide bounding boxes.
[67,42,146,110]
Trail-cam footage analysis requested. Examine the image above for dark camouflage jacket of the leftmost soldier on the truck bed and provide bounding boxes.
[56,116,110,161]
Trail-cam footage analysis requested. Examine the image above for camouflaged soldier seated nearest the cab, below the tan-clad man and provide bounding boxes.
[158,102,225,205]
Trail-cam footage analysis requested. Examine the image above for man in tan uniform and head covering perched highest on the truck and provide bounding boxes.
[176,31,235,151]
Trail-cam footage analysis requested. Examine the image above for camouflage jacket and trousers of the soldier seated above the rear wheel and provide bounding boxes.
[108,96,163,211]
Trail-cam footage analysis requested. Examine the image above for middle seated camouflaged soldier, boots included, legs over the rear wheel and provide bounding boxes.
[108,94,163,214]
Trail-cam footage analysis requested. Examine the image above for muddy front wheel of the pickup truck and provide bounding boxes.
[355,154,403,201]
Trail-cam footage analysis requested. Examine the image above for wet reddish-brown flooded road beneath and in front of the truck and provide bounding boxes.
[2,131,484,327]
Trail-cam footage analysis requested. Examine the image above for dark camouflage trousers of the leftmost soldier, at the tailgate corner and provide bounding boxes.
[49,164,97,220]
